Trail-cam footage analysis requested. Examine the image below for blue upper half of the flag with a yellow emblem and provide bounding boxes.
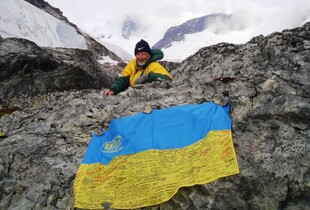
[82,103,231,164]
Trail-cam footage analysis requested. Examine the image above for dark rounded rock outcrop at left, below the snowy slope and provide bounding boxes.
[0,38,120,102]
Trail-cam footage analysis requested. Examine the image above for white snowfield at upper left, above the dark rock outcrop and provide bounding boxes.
[0,0,87,49]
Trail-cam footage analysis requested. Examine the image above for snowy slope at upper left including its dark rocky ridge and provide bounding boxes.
[0,0,129,62]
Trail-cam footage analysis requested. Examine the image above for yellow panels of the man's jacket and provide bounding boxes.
[120,58,172,87]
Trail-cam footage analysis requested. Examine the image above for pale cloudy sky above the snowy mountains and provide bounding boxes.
[47,0,310,41]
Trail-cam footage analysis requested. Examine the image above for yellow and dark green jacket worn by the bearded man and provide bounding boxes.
[110,49,172,94]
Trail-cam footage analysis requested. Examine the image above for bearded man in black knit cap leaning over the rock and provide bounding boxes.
[105,39,172,96]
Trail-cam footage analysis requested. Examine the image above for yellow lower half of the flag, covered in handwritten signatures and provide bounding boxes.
[74,130,239,209]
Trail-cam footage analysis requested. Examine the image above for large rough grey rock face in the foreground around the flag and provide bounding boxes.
[0,23,310,210]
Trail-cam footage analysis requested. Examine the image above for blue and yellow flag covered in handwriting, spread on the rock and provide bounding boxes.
[74,103,239,209]
